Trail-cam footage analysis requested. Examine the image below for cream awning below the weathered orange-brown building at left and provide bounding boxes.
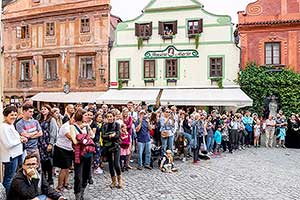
[31,92,104,103]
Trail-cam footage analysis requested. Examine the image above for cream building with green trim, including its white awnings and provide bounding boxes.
[98,0,252,107]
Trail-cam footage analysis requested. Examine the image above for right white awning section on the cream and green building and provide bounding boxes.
[160,88,253,108]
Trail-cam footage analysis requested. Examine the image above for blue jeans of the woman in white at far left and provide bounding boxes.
[3,155,22,194]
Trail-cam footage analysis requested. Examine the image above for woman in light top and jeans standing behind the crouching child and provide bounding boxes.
[160,109,175,156]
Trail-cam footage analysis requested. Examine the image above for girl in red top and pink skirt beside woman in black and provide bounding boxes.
[120,124,130,172]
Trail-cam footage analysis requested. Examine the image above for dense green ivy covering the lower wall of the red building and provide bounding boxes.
[238,62,300,116]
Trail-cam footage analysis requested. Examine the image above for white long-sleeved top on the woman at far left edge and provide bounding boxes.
[0,123,23,162]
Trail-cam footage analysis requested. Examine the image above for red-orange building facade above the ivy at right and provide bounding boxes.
[238,0,300,72]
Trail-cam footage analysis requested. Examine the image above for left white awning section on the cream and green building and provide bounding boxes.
[97,88,160,105]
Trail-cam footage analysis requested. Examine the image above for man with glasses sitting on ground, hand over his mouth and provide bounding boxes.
[7,154,66,200]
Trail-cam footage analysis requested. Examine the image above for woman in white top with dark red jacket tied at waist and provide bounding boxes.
[70,109,95,200]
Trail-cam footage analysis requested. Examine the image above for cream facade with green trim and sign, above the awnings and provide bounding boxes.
[110,0,239,87]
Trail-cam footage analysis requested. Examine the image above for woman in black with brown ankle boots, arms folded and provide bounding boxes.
[102,111,123,189]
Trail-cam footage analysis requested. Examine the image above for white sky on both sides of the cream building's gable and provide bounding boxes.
[111,0,256,23]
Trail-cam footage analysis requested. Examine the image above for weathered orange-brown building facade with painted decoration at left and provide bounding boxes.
[2,0,118,103]
